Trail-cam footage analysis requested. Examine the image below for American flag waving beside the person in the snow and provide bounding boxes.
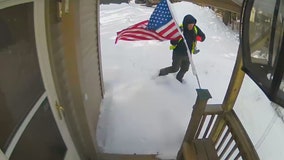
[115,0,182,43]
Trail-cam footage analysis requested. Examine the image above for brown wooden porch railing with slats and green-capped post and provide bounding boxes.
[177,89,259,160]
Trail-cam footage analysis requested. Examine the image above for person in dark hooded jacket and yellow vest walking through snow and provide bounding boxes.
[159,14,205,83]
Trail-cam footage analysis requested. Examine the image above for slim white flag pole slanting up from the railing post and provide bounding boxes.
[166,0,201,89]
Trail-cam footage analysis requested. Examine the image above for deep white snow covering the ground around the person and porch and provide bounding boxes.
[97,1,284,160]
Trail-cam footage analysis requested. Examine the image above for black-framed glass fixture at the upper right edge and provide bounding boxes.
[242,0,284,106]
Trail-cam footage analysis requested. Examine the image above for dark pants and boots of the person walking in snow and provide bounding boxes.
[159,54,190,82]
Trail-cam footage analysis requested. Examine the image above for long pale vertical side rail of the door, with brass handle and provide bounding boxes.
[33,0,80,160]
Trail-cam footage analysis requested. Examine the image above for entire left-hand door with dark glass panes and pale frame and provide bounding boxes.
[0,0,79,160]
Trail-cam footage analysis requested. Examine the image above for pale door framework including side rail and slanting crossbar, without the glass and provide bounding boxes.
[0,0,80,160]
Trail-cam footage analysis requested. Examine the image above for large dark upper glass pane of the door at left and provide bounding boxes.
[0,3,45,151]
